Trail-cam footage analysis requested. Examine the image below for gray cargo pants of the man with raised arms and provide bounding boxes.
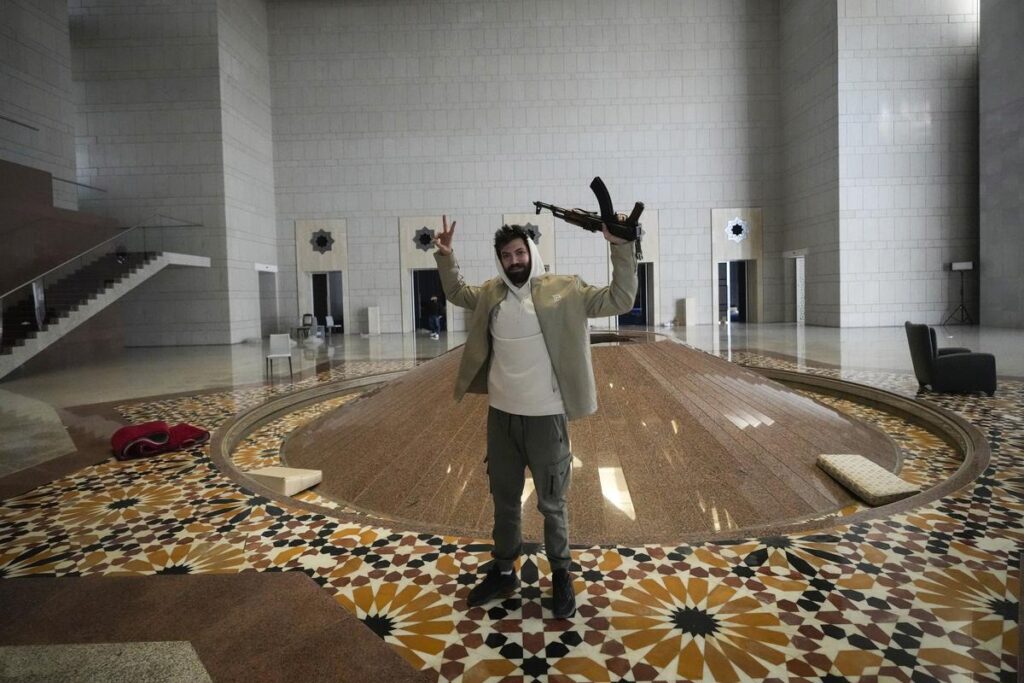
[487,408,572,570]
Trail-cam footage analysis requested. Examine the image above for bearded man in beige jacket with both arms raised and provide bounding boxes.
[434,216,637,618]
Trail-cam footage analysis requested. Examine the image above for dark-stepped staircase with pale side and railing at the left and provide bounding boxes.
[0,252,210,378]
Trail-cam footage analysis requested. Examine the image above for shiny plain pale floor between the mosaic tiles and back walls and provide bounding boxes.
[0,324,1024,408]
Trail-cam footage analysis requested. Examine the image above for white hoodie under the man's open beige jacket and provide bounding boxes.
[487,238,565,416]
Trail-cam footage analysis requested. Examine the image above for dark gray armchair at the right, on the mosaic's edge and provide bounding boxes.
[903,322,995,396]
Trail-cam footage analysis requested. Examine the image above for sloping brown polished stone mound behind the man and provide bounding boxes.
[283,342,899,544]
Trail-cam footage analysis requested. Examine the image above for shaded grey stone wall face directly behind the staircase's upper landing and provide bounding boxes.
[71,0,231,346]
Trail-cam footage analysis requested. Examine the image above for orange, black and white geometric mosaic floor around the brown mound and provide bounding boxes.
[0,353,1024,681]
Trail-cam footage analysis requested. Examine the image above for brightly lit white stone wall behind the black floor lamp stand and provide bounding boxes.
[835,0,978,327]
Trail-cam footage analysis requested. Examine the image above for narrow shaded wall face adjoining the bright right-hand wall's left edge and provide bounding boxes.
[776,0,840,327]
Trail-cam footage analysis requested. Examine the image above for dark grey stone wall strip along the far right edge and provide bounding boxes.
[978,0,1024,328]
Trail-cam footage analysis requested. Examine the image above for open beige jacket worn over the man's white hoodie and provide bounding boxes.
[434,244,637,420]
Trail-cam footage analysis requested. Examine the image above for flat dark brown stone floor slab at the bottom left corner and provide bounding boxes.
[0,571,432,682]
